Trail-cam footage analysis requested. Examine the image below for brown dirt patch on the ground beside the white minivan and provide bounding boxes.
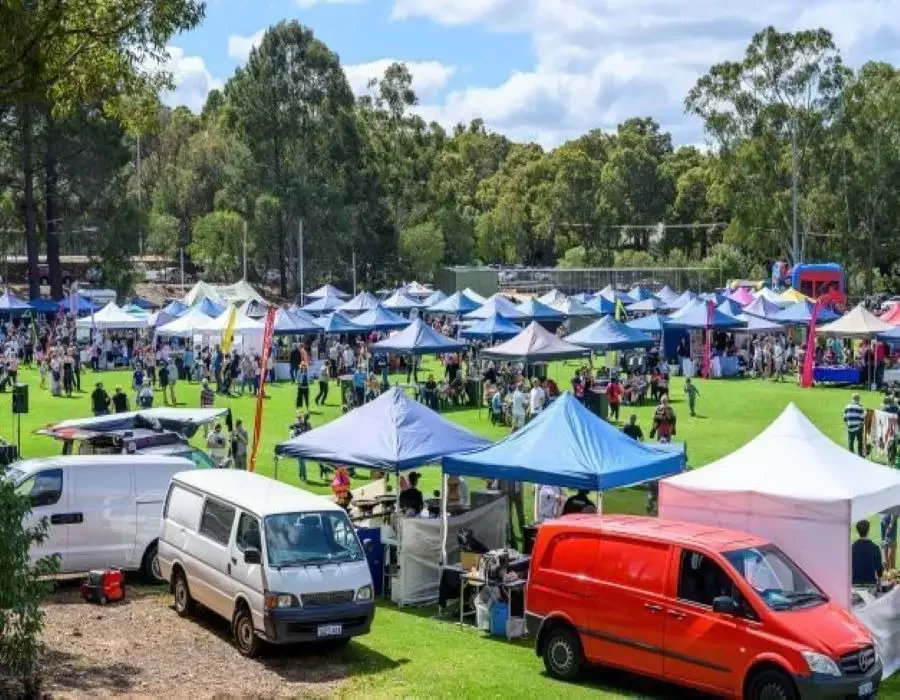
[43,587,350,699]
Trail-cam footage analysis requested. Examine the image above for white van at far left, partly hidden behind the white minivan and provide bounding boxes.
[5,455,194,581]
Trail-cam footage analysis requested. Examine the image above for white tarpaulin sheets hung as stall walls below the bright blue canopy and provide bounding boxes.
[391,498,509,605]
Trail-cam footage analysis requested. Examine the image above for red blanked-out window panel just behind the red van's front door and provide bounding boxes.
[597,538,671,595]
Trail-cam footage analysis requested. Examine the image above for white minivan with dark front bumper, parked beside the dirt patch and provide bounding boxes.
[159,470,375,656]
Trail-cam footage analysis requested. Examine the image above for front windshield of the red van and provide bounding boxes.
[723,544,828,610]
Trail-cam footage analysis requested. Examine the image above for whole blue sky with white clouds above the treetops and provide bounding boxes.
[165,0,900,147]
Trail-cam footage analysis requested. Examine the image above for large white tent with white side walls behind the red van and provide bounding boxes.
[659,403,900,609]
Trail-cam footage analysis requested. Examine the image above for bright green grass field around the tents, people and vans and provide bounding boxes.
[8,364,900,698]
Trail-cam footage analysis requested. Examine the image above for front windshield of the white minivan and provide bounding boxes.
[265,511,364,568]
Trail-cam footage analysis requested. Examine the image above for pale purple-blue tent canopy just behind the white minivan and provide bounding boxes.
[275,387,490,472]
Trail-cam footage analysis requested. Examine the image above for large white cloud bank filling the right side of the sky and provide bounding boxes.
[392,0,900,146]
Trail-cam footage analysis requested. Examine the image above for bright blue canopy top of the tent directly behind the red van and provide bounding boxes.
[442,392,684,491]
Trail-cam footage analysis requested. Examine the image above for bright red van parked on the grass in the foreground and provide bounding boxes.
[526,515,881,700]
